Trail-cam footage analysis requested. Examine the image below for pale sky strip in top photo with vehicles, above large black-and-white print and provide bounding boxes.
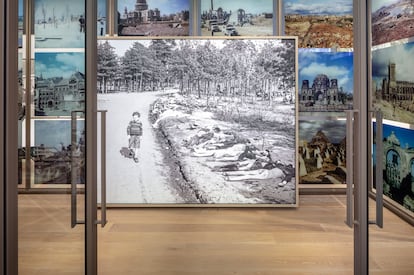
[201,0,273,14]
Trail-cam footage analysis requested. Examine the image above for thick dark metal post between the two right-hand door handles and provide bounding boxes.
[353,0,369,275]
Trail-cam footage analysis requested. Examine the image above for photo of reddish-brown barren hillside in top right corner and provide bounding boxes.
[371,0,414,45]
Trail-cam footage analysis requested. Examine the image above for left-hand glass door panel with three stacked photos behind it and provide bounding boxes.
[18,0,91,274]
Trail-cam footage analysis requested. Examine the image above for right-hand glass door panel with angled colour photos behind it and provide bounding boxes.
[367,0,414,274]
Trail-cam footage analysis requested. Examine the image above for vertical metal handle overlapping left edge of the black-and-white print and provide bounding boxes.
[96,110,107,227]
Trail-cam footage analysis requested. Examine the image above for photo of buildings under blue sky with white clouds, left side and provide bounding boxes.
[33,53,85,116]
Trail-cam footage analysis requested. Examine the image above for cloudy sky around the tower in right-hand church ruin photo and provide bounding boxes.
[372,42,414,88]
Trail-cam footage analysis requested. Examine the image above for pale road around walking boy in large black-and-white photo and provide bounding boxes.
[98,93,184,204]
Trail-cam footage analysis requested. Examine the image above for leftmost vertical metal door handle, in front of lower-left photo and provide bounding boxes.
[70,111,85,228]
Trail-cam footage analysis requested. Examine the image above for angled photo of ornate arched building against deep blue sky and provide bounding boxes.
[373,122,414,215]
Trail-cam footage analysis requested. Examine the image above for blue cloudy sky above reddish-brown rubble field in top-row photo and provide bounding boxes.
[283,0,352,15]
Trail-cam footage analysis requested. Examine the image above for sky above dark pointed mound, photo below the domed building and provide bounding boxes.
[299,120,346,144]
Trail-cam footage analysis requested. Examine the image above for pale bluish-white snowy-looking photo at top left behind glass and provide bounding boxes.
[34,0,86,48]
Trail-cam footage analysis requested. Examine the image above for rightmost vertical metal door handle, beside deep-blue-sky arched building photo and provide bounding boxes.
[370,110,384,228]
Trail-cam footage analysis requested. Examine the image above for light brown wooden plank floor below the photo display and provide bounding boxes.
[19,195,414,275]
